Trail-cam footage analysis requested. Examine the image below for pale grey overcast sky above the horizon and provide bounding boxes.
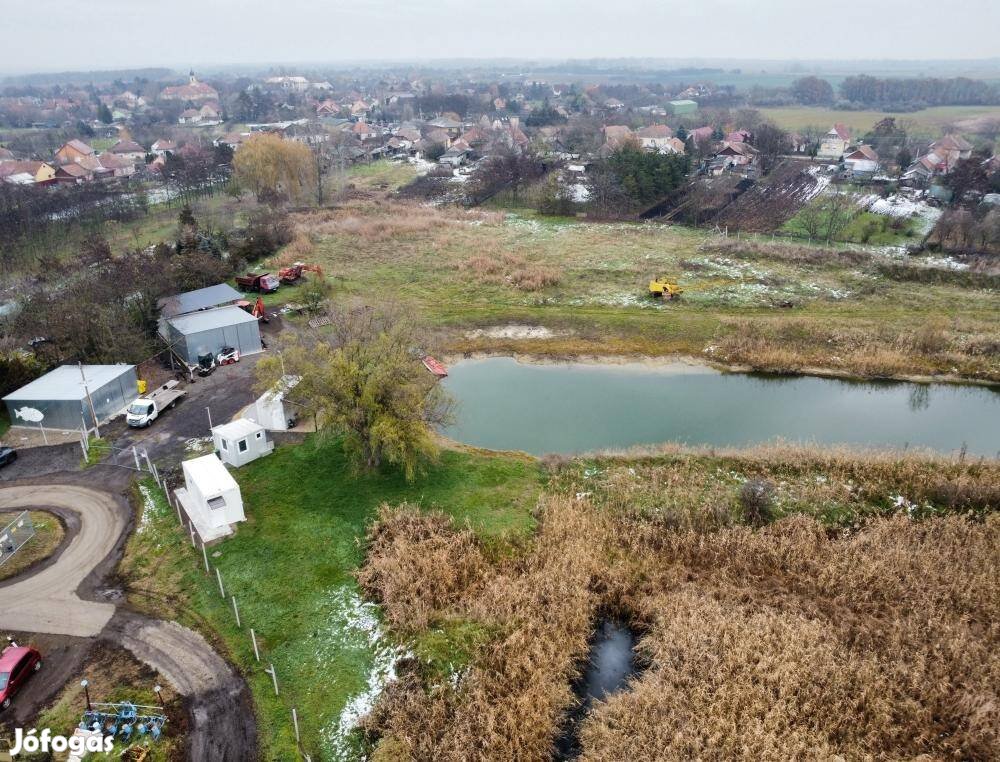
[0,0,1000,73]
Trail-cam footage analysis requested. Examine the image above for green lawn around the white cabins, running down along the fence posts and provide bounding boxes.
[121,439,542,760]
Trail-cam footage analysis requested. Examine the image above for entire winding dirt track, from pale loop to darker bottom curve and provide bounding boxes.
[0,476,258,762]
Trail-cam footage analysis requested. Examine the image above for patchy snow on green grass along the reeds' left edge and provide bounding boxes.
[316,587,409,762]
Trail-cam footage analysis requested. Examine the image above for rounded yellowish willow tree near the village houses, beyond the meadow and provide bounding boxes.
[233,132,316,204]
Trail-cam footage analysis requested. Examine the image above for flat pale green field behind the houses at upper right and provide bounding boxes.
[760,106,1000,135]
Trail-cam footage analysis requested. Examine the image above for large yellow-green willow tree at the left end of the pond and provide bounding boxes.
[257,307,451,480]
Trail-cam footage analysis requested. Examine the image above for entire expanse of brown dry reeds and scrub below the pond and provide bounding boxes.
[361,448,1000,760]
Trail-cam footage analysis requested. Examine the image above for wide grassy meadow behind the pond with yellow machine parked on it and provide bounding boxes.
[269,177,1000,380]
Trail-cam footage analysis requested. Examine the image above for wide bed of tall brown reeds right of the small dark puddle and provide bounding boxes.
[581,515,1000,760]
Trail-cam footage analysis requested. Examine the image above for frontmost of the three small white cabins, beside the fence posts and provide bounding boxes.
[174,455,246,542]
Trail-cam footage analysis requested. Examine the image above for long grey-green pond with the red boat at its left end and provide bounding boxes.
[444,357,1000,457]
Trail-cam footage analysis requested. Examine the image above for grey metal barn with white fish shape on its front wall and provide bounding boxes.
[3,364,139,430]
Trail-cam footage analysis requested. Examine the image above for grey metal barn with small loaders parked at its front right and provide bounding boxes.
[166,306,263,365]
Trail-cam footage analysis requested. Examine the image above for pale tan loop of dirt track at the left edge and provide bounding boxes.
[0,485,127,637]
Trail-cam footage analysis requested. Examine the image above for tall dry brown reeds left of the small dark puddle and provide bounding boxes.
[362,499,606,760]
